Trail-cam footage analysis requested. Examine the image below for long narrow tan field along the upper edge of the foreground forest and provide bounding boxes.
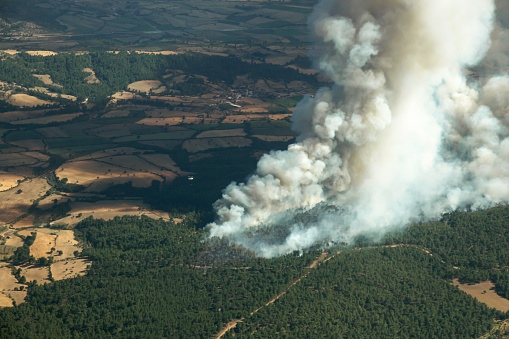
[55,200,170,225]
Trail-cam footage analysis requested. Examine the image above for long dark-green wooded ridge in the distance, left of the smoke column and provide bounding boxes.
[0,52,316,102]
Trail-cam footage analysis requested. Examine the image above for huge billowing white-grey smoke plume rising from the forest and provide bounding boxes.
[208,0,509,257]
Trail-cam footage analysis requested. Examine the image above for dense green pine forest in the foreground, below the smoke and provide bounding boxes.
[0,207,509,338]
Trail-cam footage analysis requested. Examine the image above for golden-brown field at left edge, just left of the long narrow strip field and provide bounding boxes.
[0,178,50,223]
